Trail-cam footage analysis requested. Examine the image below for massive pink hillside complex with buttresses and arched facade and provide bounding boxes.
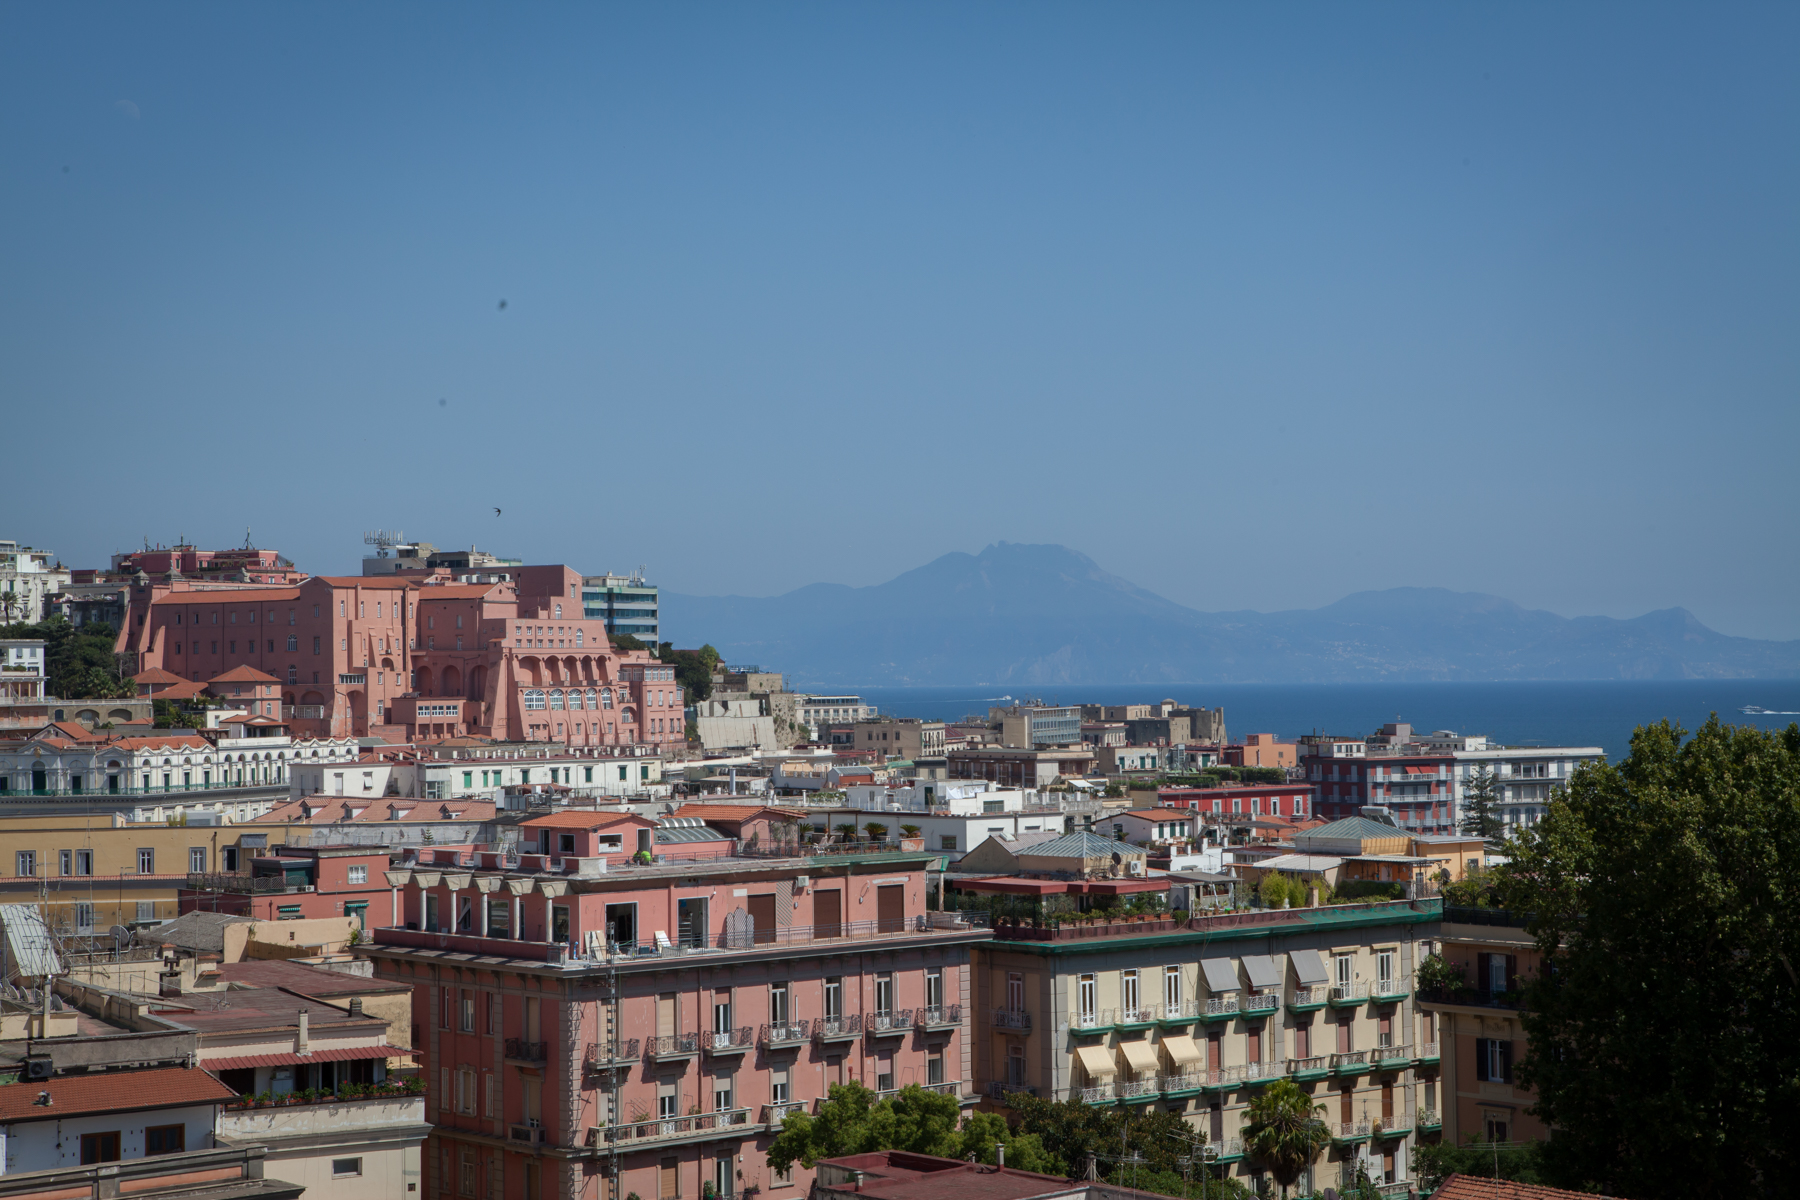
[117,567,686,747]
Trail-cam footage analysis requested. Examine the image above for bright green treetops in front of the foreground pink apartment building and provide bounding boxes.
[769,1083,1049,1171]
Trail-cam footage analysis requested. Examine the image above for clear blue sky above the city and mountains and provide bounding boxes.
[0,2,1800,637]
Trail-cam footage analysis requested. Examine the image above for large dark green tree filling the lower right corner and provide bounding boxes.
[1501,718,1800,1200]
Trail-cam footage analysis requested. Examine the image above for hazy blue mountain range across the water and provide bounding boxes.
[662,542,1800,687]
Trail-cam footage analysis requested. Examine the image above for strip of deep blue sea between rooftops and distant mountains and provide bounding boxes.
[860,680,1800,761]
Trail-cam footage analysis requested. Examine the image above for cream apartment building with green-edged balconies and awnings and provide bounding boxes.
[974,900,1442,1191]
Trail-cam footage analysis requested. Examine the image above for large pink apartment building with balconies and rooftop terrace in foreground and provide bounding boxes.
[371,849,988,1200]
